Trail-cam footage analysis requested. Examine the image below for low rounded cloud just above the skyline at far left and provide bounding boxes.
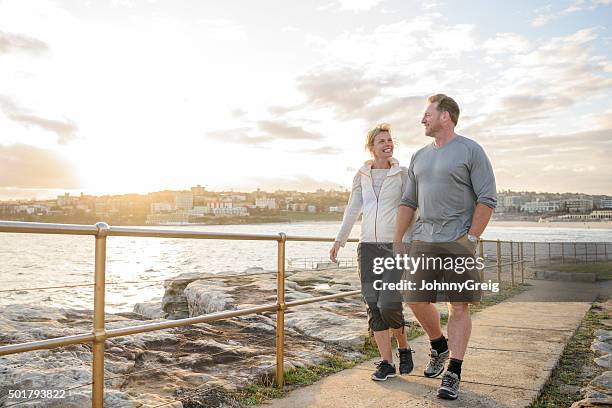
[0,144,79,189]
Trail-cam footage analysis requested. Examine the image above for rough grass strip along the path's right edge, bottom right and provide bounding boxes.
[531,306,608,408]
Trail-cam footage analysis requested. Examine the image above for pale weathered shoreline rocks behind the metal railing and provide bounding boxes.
[0,269,376,408]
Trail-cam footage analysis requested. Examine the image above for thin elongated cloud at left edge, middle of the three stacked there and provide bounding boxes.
[0,96,78,144]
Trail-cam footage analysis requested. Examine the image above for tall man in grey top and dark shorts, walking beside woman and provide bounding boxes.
[394,94,497,399]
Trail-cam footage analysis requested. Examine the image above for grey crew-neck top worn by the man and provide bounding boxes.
[400,135,497,242]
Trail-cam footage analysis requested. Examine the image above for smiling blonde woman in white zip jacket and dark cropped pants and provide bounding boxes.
[329,123,413,381]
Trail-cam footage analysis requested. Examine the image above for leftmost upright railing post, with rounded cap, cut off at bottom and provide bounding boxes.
[91,222,110,408]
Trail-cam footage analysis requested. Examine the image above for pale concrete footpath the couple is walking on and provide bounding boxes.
[269,281,610,408]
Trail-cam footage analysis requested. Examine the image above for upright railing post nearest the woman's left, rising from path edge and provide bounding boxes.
[276,232,287,388]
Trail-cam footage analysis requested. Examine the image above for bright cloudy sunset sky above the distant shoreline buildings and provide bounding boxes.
[0,0,612,200]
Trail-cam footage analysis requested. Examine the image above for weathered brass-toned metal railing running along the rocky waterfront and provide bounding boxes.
[0,221,607,408]
